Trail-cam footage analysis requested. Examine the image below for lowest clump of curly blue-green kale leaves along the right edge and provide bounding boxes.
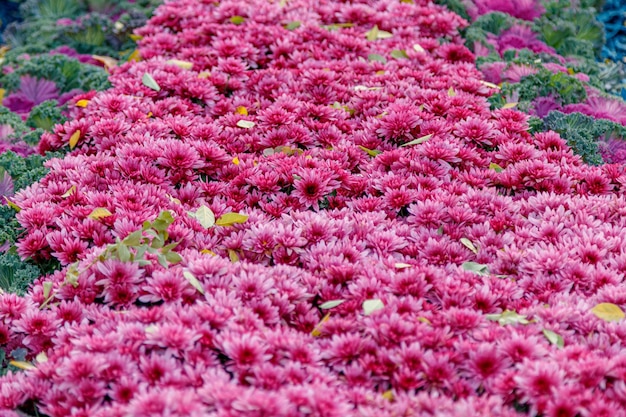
[541,111,626,165]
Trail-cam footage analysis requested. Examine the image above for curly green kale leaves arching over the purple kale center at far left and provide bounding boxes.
[0,54,110,93]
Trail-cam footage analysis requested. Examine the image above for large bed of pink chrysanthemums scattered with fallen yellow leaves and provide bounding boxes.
[0,0,626,417]
